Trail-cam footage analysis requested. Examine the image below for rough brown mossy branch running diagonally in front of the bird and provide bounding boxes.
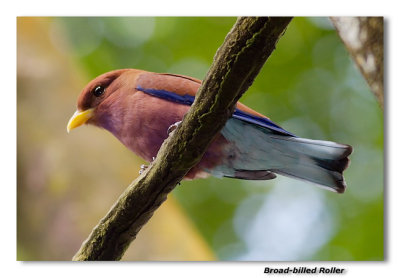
[73,17,291,260]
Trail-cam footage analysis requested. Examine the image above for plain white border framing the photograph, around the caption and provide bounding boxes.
[4,0,400,277]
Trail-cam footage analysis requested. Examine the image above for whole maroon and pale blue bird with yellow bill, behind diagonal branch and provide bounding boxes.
[67,68,353,193]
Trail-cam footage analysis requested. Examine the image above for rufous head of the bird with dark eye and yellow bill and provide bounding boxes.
[67,69,134,132]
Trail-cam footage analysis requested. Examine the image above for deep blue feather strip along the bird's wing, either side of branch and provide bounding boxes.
[136,86,295,137]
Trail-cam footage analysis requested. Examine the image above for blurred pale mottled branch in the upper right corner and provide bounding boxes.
[331,17,384,109]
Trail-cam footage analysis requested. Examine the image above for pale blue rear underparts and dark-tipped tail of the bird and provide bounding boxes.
[219,119,353,193]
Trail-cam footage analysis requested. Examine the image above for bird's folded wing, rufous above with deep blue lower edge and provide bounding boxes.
[136,72,295,136]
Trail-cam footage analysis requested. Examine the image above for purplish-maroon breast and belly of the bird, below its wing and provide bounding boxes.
[99,91,233,179]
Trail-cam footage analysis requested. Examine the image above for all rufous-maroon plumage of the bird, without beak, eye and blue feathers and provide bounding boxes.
[74,69,231,179]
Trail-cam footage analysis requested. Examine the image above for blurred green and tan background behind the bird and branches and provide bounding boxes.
[17,17,384,261]
